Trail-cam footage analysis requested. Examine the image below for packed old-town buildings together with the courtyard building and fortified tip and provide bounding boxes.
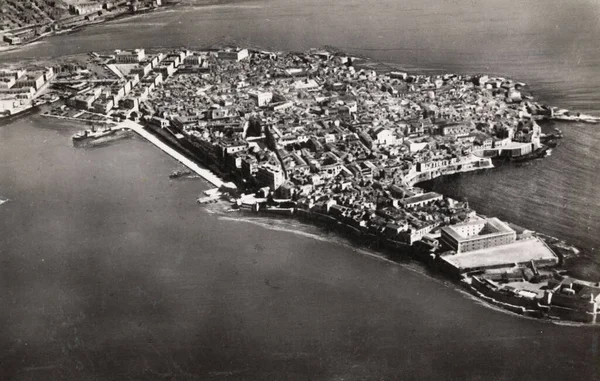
[141,50,600,321]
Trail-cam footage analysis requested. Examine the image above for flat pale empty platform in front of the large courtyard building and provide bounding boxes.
[442,238,558,271]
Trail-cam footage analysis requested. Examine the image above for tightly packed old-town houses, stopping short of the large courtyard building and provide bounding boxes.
[126,49,540,243]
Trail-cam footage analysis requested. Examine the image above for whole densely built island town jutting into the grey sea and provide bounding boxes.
[0,46,600,323]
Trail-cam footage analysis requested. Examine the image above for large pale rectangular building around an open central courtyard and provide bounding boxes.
[441,218,517,253]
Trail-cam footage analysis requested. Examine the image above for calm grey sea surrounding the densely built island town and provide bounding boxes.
[0,0,600,380]
